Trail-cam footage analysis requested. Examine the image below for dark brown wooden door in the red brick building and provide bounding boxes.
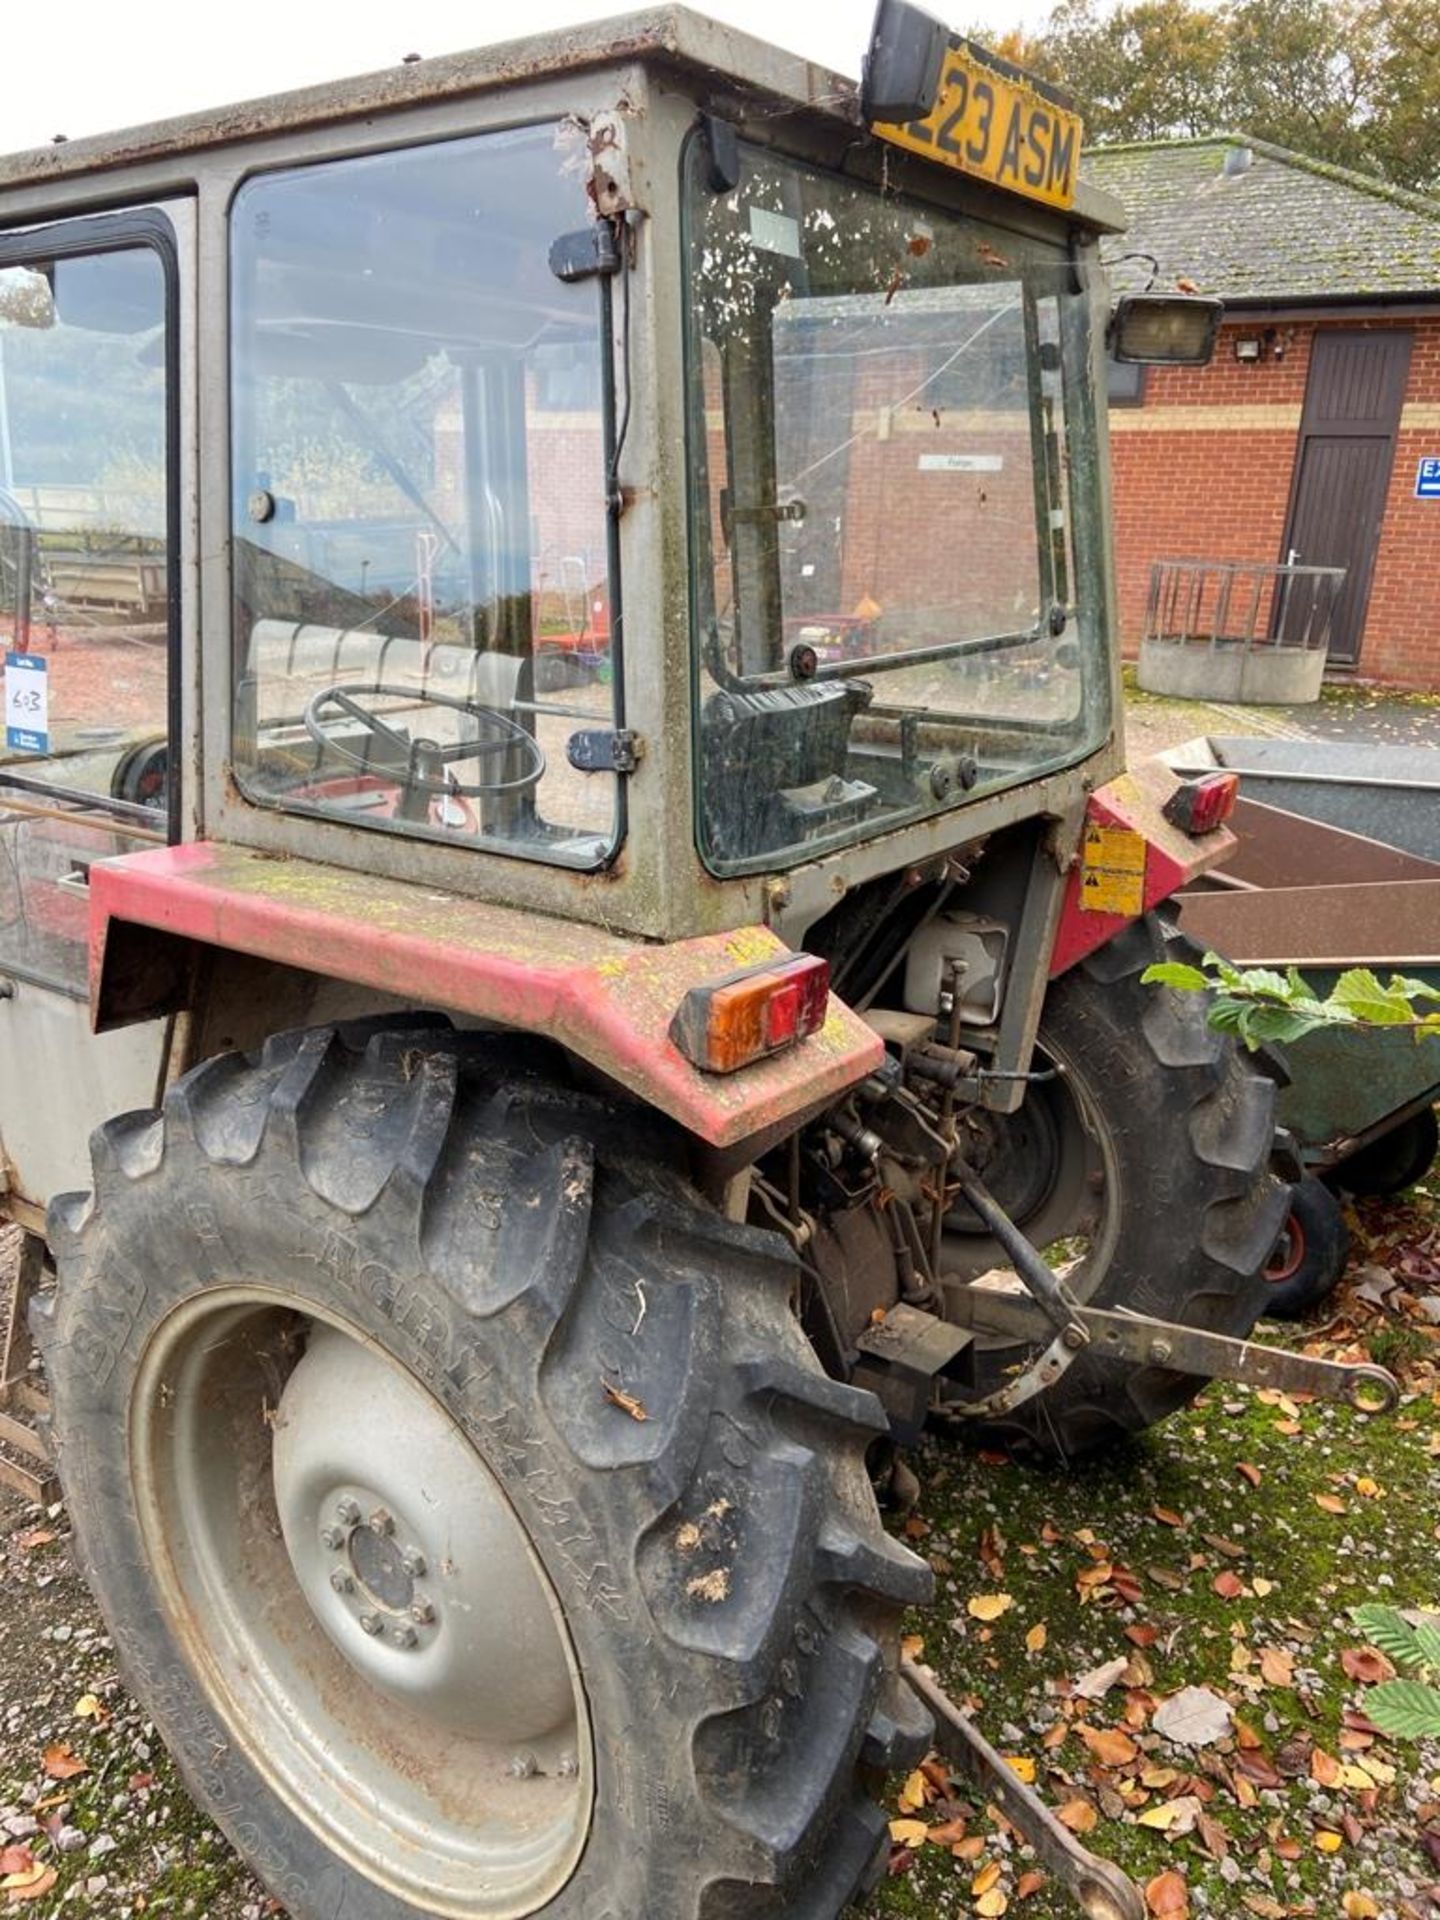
[1281,328,1411,666]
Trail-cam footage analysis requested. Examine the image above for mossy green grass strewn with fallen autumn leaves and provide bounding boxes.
[866,1183,1440,1920]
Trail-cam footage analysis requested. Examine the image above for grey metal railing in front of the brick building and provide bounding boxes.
[1144,561,1346,653]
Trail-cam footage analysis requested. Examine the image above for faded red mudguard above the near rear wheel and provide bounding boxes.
[90,841,883,1146]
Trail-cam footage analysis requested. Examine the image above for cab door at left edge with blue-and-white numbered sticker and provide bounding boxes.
[0,204,192,1223]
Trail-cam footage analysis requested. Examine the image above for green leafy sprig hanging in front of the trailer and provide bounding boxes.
[1140,952,1440,1050]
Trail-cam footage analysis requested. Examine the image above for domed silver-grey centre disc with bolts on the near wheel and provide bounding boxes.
[273,1327,574,1763]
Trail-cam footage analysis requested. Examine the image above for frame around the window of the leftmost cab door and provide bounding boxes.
[0,207,184,847]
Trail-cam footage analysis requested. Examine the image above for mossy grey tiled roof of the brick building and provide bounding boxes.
[1081,134,1440,301]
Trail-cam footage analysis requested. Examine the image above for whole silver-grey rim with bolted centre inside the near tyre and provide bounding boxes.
[131,1286,593,1920]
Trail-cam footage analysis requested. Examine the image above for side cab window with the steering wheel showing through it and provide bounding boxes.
[232,127,616,866]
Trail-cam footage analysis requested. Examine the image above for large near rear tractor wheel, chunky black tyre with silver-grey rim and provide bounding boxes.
[36,1023,929,1920]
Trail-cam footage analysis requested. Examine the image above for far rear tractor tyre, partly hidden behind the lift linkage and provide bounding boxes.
[948,916,1290,1461]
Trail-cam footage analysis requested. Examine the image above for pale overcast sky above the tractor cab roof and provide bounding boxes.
[0,0,1048,152]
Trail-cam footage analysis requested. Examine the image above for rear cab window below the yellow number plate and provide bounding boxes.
[687,140,1108,872]
